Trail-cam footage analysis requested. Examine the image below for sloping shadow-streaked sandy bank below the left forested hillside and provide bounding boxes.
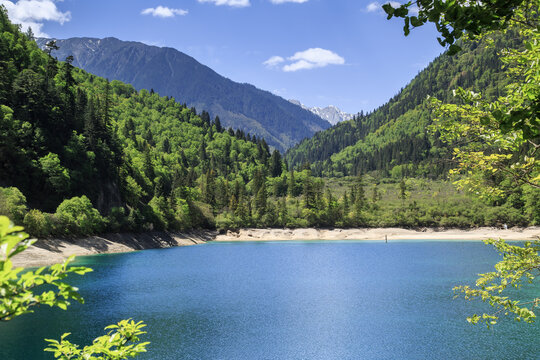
[13,231,217,267]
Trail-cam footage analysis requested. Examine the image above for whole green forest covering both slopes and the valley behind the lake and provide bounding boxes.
[0,8,540,237]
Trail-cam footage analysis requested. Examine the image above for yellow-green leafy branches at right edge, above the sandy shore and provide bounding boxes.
[432,25,540,200]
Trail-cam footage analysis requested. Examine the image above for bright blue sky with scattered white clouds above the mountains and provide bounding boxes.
[0,0,444,113]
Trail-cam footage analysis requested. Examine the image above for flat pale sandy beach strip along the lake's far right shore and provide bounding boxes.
[215,227,540,241]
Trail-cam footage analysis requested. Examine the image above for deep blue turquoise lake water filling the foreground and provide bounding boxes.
[0,241,540,360]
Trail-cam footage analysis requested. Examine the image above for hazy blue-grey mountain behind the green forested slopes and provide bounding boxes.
[37,37,330,150]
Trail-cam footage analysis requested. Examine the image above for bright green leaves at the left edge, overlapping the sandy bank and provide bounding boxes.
[0,216,92,321]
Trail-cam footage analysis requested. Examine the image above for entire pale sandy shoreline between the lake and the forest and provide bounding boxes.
[13,226,540,267]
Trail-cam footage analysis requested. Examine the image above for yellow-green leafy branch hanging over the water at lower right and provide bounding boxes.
[454,239,540,327]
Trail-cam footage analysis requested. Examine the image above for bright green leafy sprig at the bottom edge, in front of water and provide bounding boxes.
[45,319,150,360]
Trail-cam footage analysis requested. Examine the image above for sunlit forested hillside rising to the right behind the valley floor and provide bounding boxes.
[286,34,519,178]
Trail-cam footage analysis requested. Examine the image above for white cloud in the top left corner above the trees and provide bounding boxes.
[0,0,71,37]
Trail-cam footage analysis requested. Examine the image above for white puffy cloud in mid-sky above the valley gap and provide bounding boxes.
[263,48,345,72]
